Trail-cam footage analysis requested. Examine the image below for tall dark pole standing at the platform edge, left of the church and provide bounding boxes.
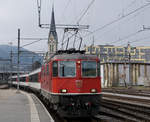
[17,29,20,92]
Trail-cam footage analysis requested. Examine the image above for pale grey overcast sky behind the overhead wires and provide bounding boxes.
[0,0,150,51]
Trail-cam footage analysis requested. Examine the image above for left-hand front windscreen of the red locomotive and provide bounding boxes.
[59,61,76,77]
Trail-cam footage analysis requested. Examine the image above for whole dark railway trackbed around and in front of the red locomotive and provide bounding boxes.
[14,85,150,122]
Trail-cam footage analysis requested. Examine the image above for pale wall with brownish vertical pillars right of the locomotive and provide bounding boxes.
[101,63,150,87]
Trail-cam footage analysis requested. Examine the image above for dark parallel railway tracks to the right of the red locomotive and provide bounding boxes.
[100,95,150,122]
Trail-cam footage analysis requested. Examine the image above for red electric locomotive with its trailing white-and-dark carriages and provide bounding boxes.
[9,50,101,117]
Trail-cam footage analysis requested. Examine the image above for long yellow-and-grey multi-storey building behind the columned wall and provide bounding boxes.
[85,44,150,63]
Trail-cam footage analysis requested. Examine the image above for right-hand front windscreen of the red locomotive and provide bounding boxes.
[82,61,97,77]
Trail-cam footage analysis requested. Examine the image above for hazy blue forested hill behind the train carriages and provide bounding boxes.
[0,45,43,71]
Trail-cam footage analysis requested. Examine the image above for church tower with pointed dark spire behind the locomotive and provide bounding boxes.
[48,8,58,57]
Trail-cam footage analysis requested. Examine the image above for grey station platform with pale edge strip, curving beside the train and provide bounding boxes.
[0,89,54,122]
